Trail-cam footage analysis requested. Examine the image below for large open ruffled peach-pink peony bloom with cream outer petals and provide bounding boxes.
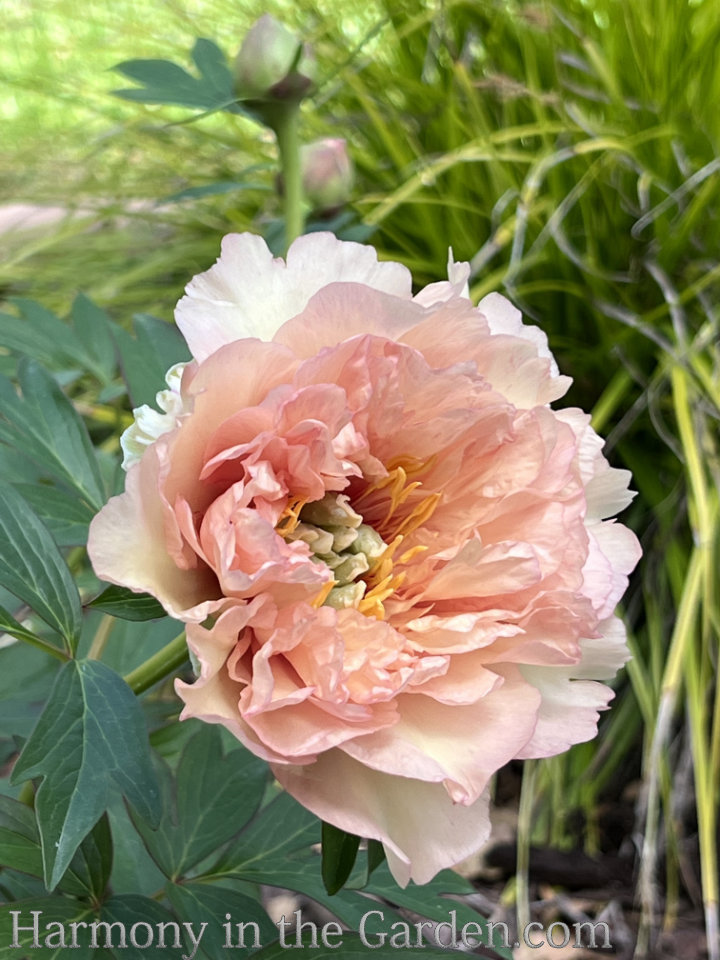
[89,234,640,885]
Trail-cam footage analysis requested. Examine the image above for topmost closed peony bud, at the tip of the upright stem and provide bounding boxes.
[235,13,314,100]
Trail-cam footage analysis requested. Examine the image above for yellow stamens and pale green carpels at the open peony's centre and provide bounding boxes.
[277,464,440,620]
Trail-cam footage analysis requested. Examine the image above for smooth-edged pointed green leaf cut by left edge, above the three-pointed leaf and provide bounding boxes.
[0,484,82,649]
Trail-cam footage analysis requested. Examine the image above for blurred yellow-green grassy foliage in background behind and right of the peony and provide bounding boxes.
[0,0,720,957]
